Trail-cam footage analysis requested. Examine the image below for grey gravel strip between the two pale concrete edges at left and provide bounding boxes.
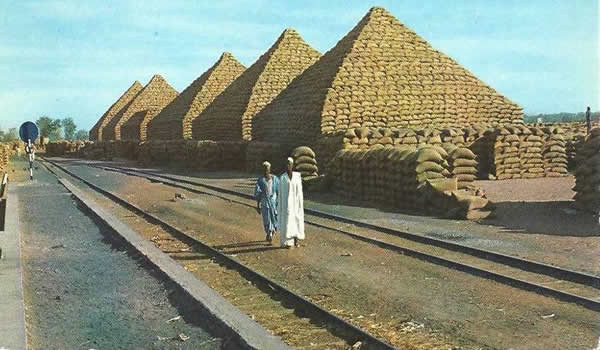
[11,159,222,349]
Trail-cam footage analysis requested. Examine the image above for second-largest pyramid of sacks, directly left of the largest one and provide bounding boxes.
[192,29,320,141]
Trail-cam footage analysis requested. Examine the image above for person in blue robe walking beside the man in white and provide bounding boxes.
[254,162,279,242]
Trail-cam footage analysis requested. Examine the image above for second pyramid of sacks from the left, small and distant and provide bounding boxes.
[106,74,178,140]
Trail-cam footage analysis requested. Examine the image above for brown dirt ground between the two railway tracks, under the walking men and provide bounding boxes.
[59,161,600,349]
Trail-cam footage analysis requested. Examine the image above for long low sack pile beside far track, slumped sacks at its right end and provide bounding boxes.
[327,146,490,219]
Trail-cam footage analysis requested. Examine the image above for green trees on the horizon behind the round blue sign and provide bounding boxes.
[0,116,89,142]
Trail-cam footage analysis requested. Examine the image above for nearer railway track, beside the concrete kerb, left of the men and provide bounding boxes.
[42,160,395,350]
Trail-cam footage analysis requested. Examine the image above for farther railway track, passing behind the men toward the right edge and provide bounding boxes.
[52,159,600,311]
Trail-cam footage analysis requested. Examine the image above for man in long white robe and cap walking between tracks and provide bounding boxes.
[277,158,304,248]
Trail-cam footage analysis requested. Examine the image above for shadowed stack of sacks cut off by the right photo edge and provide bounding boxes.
[573,128,600,214]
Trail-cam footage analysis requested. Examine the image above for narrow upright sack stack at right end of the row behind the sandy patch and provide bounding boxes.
[542,128,569,177]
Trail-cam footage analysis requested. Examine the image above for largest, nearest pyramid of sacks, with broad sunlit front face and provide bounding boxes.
[253,7,523,145]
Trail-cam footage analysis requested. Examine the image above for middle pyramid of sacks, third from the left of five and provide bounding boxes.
[148,52,246,140]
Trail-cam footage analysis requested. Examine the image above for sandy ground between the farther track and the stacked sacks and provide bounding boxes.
[71,160,600,275]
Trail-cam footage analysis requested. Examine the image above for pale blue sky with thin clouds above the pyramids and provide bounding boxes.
[0,0,600,130]
